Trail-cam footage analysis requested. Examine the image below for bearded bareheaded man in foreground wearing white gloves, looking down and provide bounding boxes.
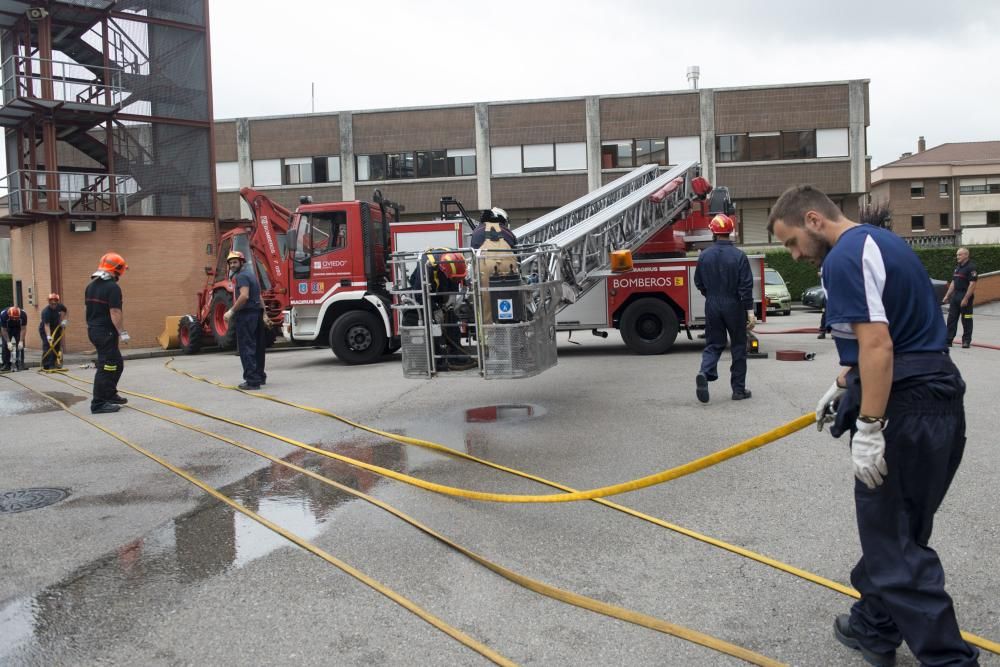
[768,185,979,666]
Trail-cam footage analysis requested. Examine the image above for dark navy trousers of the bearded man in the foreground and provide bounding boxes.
[850,370,979,666]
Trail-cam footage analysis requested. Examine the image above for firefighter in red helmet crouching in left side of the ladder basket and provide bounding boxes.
[403,248,476,371]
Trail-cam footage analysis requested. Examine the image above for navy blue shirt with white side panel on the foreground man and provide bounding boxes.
[823,225,947,366]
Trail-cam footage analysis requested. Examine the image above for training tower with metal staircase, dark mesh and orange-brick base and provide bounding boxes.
[0,0,217,351]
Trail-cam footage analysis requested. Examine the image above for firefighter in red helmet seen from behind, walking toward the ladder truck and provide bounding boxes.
[694,213,757,403]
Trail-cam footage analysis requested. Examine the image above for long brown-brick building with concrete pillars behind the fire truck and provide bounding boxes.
[215,80,869,243]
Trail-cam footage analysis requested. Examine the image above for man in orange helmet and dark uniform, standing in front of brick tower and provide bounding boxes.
[84,252,129,414]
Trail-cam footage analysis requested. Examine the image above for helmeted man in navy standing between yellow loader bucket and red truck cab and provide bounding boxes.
[224,250,267,389]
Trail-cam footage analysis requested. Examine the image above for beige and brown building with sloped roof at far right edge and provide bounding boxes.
[871,137,1000,245]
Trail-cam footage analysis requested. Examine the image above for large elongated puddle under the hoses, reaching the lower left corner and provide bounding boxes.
[0,438,408,663]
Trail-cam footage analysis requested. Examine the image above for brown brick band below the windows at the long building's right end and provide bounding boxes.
[716,161,851,199]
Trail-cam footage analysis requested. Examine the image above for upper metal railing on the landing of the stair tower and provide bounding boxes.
[2,56,124,106]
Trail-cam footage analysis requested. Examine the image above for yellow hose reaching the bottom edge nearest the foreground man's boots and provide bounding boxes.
[29,376,784,667]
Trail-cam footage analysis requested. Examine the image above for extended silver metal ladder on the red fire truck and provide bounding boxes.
[514,162,698,303]
